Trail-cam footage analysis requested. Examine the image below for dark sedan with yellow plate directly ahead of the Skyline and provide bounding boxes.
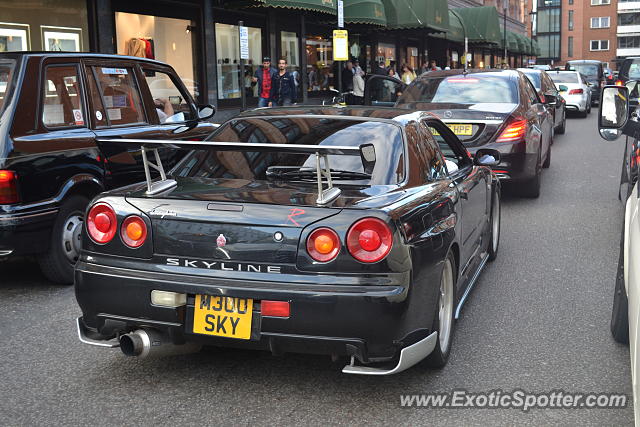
[365,70,556,197]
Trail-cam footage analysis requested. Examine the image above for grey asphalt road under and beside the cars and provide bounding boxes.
[0,110,633,426]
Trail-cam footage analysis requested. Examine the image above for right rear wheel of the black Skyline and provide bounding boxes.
[425,251,456,369]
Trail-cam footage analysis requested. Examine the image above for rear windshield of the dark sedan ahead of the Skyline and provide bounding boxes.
[398,74,518,104]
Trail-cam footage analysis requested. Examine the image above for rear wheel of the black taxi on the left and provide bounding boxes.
[38,196,89,285]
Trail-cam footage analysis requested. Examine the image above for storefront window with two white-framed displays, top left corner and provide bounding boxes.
[0,0,89,52]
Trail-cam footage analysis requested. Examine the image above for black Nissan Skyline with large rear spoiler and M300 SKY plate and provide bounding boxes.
[75,107,500,375]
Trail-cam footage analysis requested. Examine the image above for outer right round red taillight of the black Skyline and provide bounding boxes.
[347,218,393,263]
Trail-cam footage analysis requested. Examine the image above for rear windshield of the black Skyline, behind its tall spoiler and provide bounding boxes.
[173,117,404,186]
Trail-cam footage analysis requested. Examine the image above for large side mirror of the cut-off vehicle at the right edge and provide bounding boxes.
[598,86,629,141]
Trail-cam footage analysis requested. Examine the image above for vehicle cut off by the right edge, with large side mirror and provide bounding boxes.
[598,82,640,425]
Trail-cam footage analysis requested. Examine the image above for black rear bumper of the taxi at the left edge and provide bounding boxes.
[0,207,58,257]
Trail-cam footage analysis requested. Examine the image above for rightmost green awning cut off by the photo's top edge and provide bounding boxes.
[380,0,449,32]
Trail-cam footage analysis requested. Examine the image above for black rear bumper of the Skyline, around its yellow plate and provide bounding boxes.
[75,260,424,363]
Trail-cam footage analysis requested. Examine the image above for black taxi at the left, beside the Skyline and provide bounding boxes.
[0,52,214,283]
